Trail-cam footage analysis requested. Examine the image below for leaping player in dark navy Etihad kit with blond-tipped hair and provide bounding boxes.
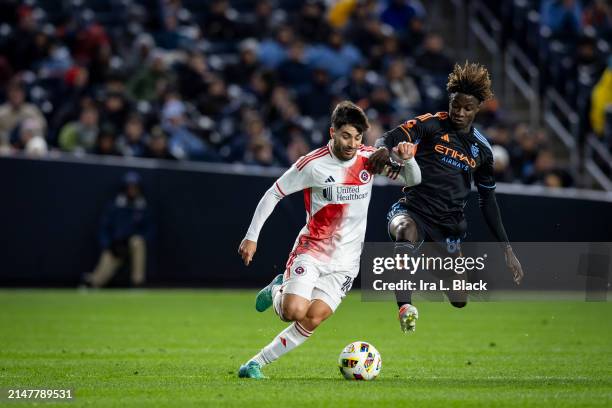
[369,62,523,332]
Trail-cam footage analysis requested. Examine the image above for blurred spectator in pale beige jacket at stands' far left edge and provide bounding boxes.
[0,80,47,147]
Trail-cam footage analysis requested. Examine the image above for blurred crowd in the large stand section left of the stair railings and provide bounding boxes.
[0,0,610,186]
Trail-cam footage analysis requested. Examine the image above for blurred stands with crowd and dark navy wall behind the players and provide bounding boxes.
[0,0,612,285]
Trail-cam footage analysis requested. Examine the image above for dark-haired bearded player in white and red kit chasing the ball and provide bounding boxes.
[238,101,421,379]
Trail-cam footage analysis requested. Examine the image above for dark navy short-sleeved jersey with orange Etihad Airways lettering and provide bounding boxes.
[376,112,495,232]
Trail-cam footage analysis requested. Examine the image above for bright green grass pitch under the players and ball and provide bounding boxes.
[0,290,612,408]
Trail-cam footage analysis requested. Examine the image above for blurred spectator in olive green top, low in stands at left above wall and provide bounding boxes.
[59,106,99,153]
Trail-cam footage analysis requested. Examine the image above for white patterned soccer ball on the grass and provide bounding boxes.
[338,341,382,381]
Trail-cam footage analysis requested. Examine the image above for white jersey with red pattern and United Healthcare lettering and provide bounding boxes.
[246,141,420,275]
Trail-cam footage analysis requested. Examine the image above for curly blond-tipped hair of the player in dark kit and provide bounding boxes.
[446,61,493,102]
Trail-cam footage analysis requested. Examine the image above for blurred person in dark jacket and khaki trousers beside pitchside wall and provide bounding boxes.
[83,172,153,288]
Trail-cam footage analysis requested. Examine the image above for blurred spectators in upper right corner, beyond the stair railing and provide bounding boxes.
[487,0,612,145]
